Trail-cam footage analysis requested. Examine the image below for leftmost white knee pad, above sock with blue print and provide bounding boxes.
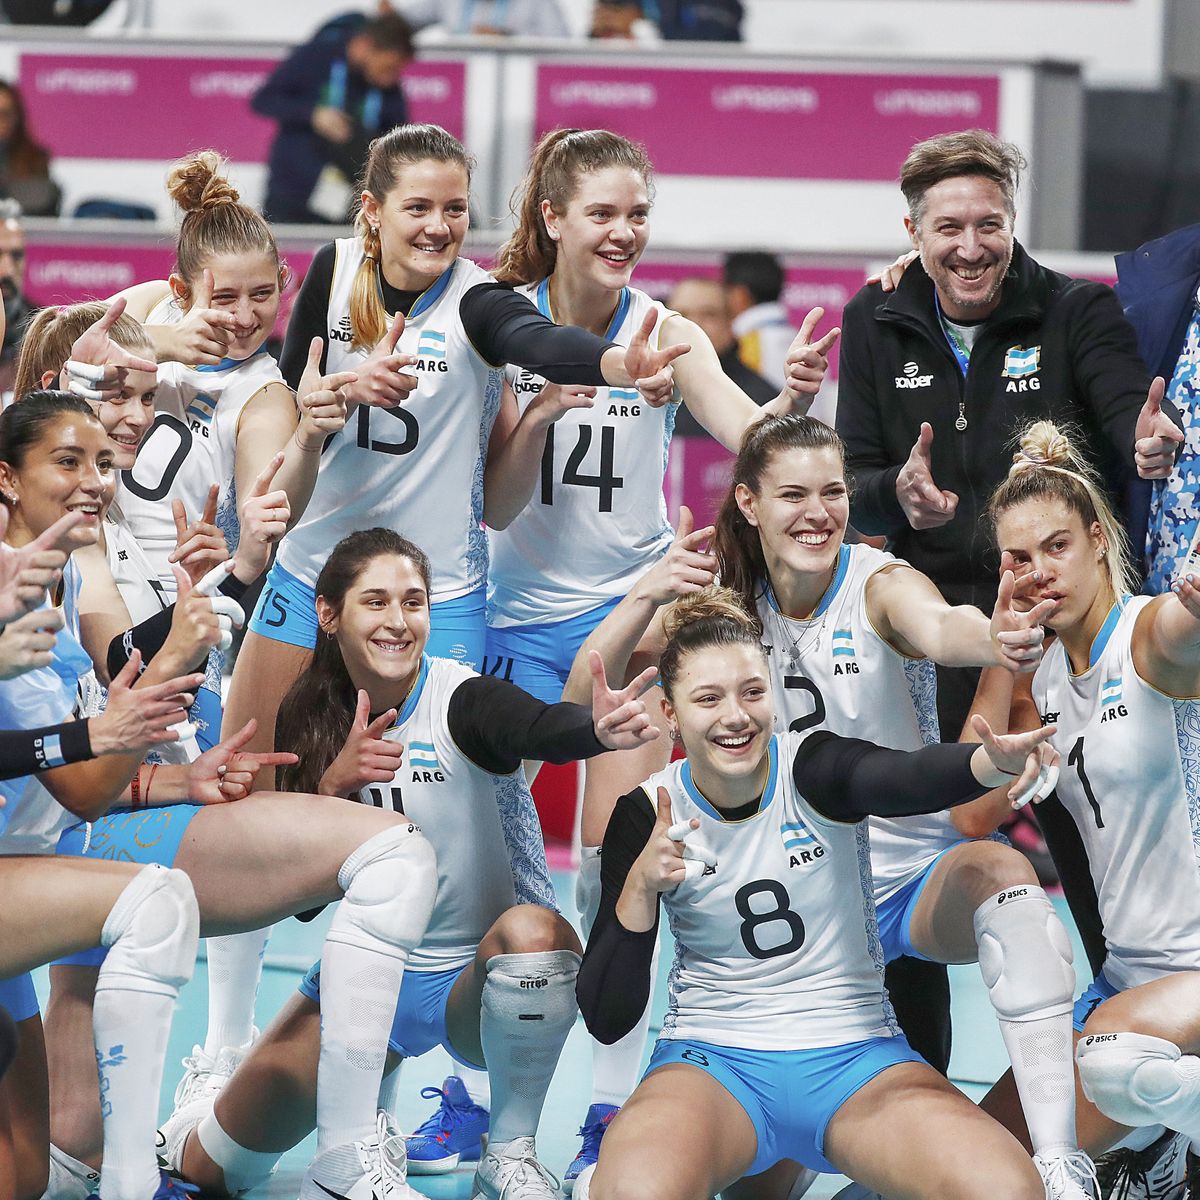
[96,865,200,996]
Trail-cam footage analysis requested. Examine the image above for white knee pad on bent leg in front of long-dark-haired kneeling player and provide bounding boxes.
[326,824,438,959]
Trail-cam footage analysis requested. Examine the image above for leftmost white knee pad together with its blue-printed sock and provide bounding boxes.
[92,866,199,1200]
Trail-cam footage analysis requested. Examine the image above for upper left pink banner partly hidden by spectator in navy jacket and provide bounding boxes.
[19,48,467,162]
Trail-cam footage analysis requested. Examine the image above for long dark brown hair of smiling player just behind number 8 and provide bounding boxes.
[713,413,852,612]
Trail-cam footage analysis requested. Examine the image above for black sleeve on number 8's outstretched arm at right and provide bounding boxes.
[792,731,990,821]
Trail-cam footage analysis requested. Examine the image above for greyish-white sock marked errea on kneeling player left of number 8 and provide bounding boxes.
[479,950,580,1145]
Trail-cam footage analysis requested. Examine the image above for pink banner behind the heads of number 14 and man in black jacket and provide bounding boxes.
[535,64,1000,182]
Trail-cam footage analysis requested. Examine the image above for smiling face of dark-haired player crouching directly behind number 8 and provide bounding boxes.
[737,446,850,600]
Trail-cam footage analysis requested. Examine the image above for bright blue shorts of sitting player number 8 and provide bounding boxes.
[642,1036,924,1175]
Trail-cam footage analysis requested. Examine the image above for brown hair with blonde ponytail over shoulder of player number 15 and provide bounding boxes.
[350,125,475,348]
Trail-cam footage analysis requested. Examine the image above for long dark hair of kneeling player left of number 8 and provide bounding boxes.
[275,528,431,792]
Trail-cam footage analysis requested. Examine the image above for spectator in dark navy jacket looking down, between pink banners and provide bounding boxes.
[251,12,413,223]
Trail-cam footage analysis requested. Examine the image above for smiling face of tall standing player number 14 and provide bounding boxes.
[541,167,650,290]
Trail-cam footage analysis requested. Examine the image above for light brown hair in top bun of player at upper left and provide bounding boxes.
[167,150,284,302]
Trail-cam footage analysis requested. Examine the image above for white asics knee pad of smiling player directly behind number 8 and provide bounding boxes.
[974,883,1075,1021]
